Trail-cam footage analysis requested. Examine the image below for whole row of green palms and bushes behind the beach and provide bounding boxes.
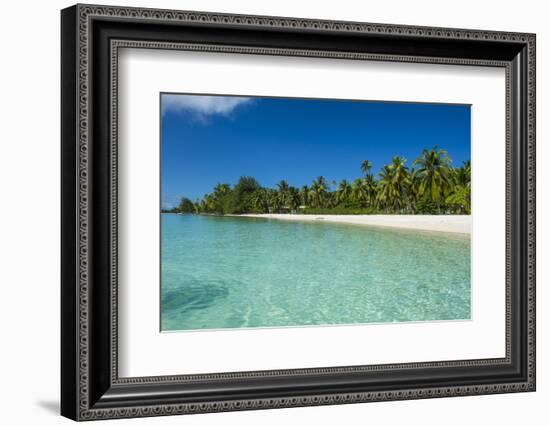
[170,146,471,214]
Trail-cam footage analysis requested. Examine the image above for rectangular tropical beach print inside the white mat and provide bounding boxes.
[160,93,471,331]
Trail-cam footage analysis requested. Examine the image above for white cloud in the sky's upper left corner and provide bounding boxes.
[162,94,252,119]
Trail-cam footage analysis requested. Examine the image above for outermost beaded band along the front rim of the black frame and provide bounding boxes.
[68,5,535,420]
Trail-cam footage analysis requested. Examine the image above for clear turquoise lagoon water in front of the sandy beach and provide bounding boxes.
[161,214,471,331]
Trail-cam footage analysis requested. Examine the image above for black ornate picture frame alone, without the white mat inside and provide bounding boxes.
[61,5,536,420]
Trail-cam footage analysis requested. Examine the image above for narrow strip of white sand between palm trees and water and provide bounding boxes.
[231,214,472,234]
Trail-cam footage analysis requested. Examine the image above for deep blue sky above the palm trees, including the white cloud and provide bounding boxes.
[161,94,470,207]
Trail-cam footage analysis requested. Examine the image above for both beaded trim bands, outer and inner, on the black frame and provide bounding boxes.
[77,5,535,420]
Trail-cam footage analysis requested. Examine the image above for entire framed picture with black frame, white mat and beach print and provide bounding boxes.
[61,5,535,420]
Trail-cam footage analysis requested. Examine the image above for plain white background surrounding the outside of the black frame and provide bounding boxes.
[0,0,550,426]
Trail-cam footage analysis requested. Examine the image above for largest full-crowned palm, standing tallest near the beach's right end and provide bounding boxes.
[413,145,451,212]
